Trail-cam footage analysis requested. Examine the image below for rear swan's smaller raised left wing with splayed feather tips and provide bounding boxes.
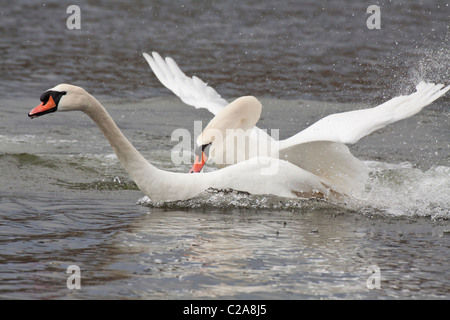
[143,52,228,115]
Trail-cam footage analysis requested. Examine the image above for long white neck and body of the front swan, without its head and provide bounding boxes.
[72,90,336,201]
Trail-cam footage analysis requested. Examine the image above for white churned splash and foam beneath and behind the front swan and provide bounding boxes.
[137,161,450,219]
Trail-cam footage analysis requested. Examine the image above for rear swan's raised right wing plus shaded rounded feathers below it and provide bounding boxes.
[278,82,450,195]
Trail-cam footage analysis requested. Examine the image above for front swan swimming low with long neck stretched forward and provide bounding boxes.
[28,84,341,201]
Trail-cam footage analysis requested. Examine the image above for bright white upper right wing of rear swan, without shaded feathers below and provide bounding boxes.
[280,82,450,149]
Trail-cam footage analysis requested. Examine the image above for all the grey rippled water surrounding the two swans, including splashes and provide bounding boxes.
[0,0,450,299]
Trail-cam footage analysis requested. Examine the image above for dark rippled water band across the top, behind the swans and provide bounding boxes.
[0,1,450,101]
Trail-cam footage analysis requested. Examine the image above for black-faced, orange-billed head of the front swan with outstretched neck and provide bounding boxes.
[28,84,90,119]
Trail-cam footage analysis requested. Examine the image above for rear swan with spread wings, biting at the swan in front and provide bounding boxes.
[143,52,450,194]
